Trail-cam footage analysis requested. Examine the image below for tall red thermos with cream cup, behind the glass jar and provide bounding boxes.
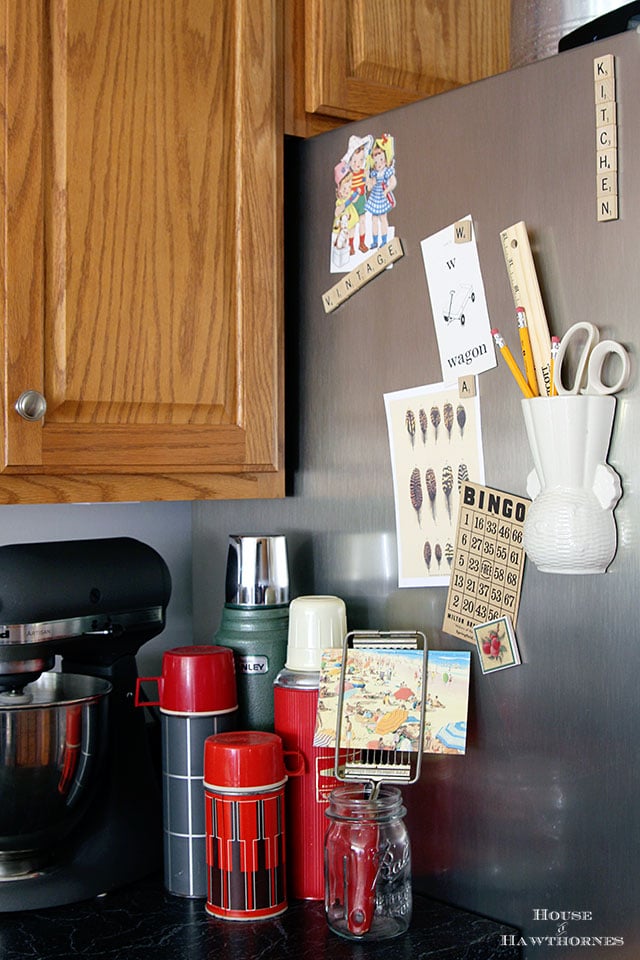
[274,596,347,900]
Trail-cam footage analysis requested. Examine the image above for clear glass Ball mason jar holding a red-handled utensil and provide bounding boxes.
[324,783,412,941]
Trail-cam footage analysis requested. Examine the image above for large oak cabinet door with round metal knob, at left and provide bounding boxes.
[0,0,284,503]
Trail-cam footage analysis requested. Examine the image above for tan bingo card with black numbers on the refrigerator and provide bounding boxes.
[443,482,529,643]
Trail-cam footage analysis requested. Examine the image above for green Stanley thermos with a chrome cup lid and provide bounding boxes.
[214,534,289,731]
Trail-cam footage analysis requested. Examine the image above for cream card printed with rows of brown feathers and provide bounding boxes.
[384,383,484,587]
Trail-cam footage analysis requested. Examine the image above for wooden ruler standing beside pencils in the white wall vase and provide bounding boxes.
[500,220,551,397]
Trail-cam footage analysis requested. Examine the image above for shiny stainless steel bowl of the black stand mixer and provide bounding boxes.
[0,672,111,879]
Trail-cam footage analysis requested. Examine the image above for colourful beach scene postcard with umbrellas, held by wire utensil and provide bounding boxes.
[314,648,471,753]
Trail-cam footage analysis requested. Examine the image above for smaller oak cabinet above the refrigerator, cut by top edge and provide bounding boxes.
[285,0,510,137]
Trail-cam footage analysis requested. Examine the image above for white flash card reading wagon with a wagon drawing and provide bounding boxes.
[421,216,497,380]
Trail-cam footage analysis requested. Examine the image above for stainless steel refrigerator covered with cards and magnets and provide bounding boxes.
[194,32,640,958]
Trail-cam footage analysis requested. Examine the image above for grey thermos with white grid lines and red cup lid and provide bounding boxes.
[136,646,238,897]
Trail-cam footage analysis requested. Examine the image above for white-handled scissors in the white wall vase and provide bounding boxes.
[553,322,631,397]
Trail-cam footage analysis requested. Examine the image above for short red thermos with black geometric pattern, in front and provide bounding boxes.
[204,731,296,920]
